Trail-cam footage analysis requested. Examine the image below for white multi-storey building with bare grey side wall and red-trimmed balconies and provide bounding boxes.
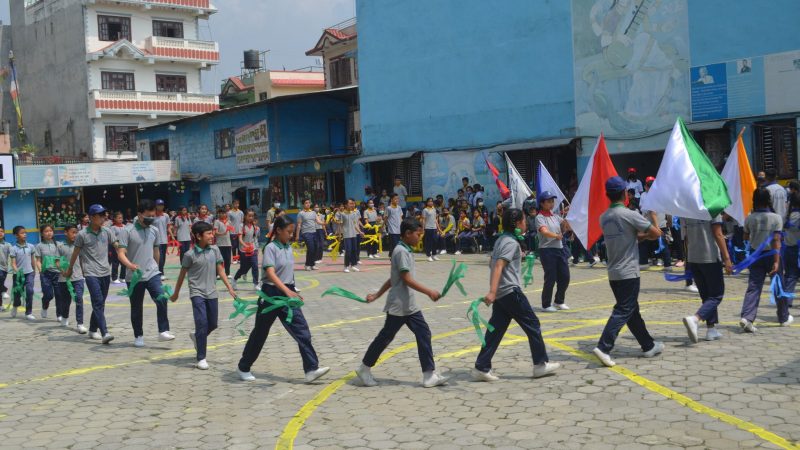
[11,0,219,160]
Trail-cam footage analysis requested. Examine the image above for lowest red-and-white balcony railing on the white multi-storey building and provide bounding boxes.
[90,89,219,117]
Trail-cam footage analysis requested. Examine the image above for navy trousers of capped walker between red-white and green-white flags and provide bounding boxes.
[597,277,655,354]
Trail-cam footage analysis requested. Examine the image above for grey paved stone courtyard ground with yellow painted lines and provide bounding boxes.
[0,251,800,449]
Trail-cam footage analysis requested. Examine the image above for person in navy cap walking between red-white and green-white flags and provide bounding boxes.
[593,177,664,367]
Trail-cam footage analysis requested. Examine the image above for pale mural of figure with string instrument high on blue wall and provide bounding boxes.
[572,0,690,136]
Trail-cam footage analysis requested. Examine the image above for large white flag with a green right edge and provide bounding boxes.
[640,117,731,220]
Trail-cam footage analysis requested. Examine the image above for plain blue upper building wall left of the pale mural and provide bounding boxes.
[357,0,574,154]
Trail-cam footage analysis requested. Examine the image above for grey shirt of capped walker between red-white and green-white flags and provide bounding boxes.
[600,204,650,281]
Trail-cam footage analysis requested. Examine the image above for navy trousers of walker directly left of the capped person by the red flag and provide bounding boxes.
[475,290,560,372]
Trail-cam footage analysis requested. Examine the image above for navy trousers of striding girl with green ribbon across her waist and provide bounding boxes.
[239,284,320,373]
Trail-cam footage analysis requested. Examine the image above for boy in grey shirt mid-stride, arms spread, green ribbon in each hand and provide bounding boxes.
[356,219,447,387]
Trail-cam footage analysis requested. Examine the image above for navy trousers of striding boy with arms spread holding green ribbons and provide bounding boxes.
[362,311,436,372]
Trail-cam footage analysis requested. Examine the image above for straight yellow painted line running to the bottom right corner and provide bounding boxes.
[550,341,800,449]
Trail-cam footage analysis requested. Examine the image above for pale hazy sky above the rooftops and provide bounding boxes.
[0,0,355,93]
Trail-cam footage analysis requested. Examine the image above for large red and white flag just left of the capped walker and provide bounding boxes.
[567,134,617,248]
